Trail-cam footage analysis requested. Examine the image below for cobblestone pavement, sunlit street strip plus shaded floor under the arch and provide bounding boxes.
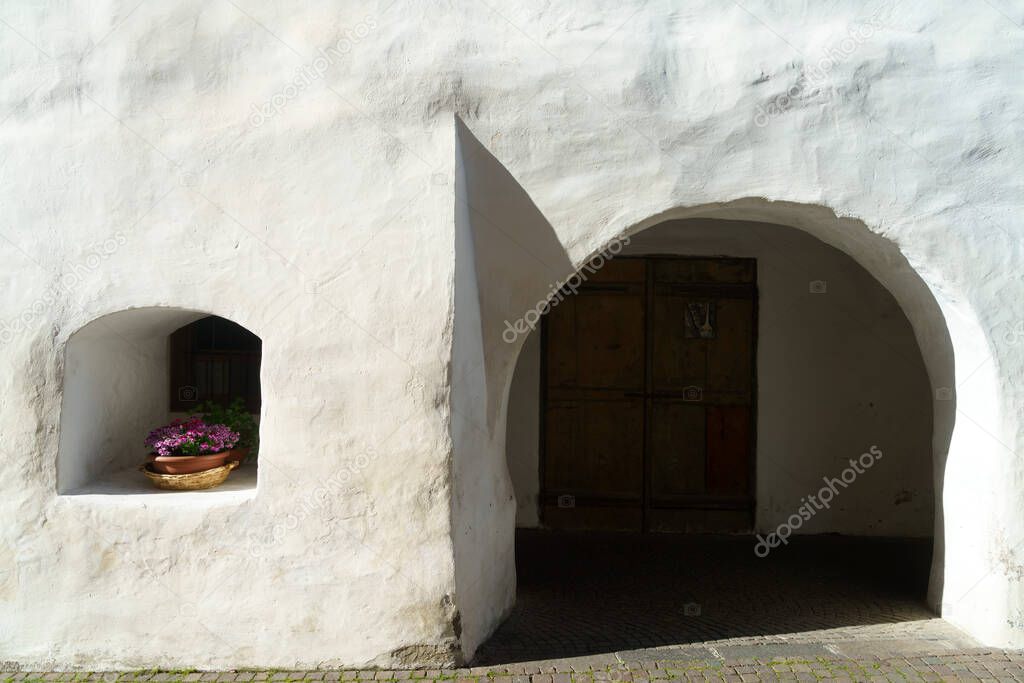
[8,532,1024,683]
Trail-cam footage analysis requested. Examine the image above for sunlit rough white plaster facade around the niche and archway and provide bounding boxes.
[0,0,1024,670]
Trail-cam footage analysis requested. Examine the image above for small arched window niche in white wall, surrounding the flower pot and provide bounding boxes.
[56,307,262,496]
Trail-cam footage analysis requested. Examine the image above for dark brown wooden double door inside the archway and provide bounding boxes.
[541,257,757,531]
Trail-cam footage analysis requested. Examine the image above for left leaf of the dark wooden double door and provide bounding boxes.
[541,259,646,530]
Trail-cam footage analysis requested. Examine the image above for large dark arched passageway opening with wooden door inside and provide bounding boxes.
[471,218,968,663]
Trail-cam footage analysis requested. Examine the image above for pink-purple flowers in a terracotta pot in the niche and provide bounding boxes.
[145,415,239,474]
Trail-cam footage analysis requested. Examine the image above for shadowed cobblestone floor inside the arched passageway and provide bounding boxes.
[476,529,937,665]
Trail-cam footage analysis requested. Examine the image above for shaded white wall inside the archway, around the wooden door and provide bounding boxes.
[506,220,934,537]
